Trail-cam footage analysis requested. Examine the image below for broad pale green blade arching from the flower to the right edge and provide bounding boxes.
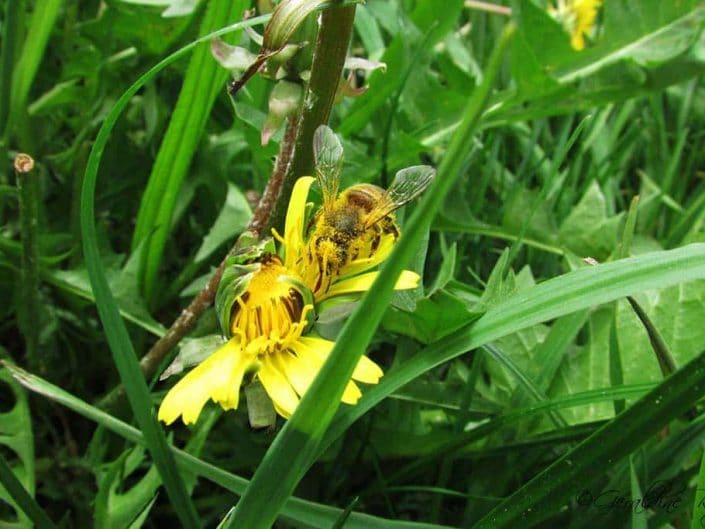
[320,244,705,463]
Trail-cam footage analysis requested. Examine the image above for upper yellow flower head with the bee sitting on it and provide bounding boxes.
[275,176,420,304]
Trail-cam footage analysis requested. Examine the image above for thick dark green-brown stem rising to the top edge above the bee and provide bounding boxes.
[270,5,355,230]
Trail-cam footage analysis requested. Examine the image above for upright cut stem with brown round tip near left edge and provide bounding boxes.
[15,154,40,369]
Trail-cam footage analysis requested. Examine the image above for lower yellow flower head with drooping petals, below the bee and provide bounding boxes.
[159,256,383,424]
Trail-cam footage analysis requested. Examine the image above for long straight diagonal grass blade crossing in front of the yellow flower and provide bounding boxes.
[226,20,514,529]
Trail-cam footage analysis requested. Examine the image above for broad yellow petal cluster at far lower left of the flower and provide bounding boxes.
[158,339,248,424]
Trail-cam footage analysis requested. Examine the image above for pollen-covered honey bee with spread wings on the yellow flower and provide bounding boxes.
[309,125,435,284]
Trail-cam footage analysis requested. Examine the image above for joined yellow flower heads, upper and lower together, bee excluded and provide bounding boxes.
[158,177,419,424]
